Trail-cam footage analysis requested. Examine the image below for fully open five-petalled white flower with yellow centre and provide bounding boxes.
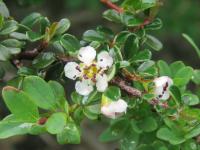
[64,46,113,96]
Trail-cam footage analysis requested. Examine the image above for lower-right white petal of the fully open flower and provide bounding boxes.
[96,74,108,92]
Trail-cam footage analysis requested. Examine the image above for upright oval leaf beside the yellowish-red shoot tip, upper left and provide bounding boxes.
[56,18,70,35]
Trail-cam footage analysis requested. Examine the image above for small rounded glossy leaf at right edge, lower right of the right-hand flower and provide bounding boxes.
[182,93,199,106]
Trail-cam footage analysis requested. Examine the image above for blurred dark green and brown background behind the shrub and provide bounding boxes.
[0,0,200,150]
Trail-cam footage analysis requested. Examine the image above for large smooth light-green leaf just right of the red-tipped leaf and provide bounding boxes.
[23,76,57,109]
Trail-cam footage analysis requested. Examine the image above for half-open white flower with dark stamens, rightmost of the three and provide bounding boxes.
[153,76,173,100]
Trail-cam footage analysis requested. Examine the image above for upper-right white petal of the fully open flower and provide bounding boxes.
[97,51,113,69]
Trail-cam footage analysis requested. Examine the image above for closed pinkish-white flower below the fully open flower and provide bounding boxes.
[101,99,128,119]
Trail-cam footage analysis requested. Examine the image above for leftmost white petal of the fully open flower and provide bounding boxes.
[64,62,82,80]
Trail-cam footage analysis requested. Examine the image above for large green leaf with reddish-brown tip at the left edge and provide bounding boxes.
[2,86,39,122]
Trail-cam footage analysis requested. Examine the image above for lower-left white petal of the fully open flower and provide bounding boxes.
[75,80,93,96]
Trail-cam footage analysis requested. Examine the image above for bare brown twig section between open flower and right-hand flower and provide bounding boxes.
[111,77,142,97]
